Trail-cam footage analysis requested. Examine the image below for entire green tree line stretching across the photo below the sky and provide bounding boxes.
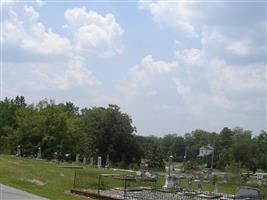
[0,96,267,171]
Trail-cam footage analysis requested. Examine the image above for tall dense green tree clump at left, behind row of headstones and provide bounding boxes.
[0,97,141,167]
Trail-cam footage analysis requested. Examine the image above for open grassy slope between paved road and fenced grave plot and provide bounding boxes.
[0,155,102,200]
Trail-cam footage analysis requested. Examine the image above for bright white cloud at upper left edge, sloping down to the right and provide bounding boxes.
[1,6,71,59]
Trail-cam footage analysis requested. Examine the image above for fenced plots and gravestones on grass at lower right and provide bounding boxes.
[71,155,267,200]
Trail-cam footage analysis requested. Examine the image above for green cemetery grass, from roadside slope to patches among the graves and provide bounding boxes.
[0,155,267,200]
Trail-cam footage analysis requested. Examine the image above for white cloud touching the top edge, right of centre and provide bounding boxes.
[139,0,198,37]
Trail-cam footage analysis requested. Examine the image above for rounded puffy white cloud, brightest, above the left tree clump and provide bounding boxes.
[64,7,124,58]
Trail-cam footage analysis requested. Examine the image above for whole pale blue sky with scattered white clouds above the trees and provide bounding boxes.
[0,0,267,136]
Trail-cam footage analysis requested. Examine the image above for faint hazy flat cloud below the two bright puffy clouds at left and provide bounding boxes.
[5,56,101,92]
